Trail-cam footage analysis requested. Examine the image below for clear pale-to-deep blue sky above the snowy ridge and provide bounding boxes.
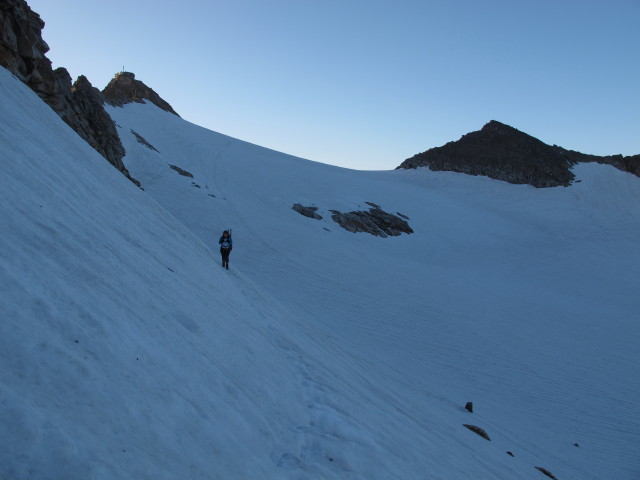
[27,0,640,170]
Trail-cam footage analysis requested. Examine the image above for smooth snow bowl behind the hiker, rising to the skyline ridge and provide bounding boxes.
[108,99,640,478]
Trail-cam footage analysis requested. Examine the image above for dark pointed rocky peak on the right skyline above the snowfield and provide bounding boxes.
[397,120,640,188]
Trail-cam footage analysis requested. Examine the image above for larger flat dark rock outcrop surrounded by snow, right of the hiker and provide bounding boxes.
[331,202,413,238]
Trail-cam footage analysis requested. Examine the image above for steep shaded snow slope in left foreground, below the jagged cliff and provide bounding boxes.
[0,64,556,479]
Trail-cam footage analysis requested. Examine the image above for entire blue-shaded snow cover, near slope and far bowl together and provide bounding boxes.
[0,64,640,480]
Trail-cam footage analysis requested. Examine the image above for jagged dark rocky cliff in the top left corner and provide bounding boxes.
[0,0,140,185]
